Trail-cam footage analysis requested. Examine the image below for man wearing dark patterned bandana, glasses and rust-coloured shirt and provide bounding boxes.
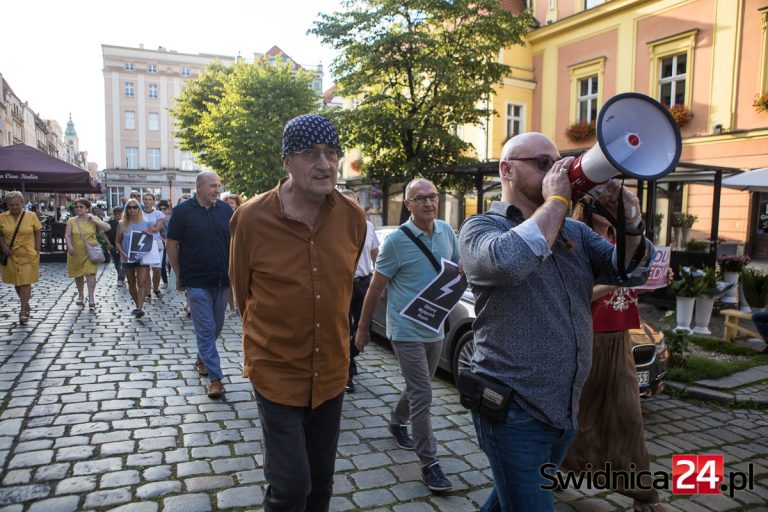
[229,114,366,512]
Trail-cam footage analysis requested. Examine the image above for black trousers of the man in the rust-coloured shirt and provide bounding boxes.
[256,391,344,512]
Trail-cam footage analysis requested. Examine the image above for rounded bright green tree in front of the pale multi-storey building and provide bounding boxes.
[172,57,318,196]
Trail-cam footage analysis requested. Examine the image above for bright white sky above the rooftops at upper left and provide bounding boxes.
[0,0,341,169]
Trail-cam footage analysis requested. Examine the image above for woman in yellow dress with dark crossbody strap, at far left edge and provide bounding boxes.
[0,191,43,325]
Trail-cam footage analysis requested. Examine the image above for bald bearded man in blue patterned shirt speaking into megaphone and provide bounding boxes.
[459,133,655,511]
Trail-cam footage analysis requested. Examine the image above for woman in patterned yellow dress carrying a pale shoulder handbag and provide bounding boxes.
[64,197,109,309]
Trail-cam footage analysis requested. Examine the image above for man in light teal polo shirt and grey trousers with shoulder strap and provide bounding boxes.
[355,179,459,491]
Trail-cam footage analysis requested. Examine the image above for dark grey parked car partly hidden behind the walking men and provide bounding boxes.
[371,226,669,398]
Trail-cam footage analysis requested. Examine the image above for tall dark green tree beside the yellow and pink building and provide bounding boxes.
[310,0,532,185]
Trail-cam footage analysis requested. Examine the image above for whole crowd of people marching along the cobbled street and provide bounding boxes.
[0,114,756,512]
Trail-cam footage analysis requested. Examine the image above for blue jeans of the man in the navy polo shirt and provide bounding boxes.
[187,286,230,382]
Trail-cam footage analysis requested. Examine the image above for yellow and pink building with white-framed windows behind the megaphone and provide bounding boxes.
[504,0,768,258]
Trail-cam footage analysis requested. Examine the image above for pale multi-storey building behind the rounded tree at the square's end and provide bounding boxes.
[102,44,323,207]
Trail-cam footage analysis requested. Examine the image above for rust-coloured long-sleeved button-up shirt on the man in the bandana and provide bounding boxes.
[229,182,366,408]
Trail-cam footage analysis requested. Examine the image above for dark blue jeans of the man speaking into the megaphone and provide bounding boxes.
[472,402,576,512]
